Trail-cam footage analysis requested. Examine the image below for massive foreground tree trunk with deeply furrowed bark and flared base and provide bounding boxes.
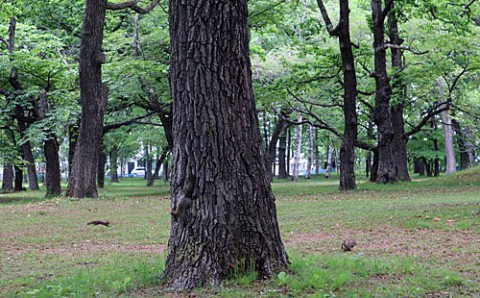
[165,0,288,290]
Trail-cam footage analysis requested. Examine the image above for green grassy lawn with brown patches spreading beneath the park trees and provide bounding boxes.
[0,168,480,297]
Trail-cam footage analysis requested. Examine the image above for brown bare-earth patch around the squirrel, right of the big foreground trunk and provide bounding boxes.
[283,226,480,264]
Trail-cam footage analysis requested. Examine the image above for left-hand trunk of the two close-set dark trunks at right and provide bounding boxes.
[371,0,397,183]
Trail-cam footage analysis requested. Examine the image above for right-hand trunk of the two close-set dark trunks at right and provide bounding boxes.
[388,0,410,181]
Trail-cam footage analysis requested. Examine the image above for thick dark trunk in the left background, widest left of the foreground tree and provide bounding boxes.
[66,0,108,198]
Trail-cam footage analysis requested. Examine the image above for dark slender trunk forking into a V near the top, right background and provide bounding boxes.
[317,0,358,190]
